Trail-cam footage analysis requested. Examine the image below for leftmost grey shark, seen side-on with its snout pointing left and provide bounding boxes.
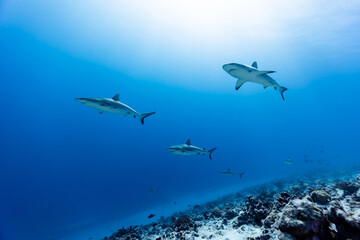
[75,94,155,124]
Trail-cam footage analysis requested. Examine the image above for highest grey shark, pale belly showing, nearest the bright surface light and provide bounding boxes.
[222,62,287,100]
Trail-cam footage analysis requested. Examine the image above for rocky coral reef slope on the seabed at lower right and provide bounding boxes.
[105,172,360,240]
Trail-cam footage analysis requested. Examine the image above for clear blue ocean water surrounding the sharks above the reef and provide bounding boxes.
[0,0,360,240]
